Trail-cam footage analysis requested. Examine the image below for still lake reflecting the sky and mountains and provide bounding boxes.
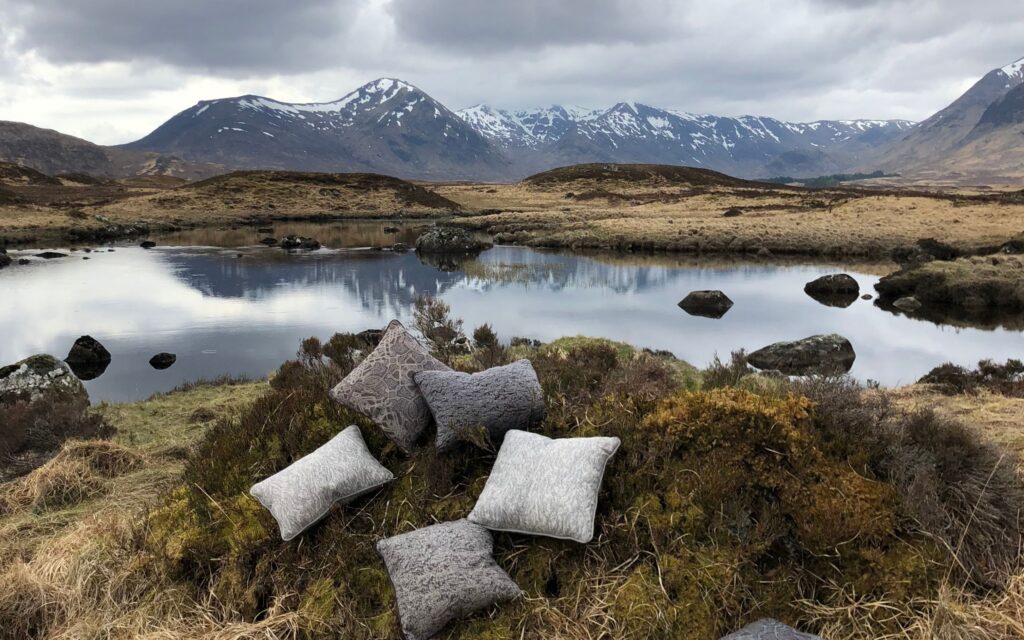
[0,222,1024,401]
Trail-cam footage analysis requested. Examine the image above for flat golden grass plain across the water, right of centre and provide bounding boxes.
[436,181,1024,256]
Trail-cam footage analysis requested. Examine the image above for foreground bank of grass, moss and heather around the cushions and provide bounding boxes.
[0,309,1024,640]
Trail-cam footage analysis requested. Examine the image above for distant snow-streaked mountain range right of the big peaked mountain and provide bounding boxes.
[458,102,913,177]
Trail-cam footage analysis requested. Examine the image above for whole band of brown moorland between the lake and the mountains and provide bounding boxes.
[0,160,1024,257]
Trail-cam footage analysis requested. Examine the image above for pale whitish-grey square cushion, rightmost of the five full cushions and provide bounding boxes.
[469,430,618,543]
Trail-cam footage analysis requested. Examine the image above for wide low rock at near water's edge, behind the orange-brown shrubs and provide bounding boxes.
[746,334,857,376]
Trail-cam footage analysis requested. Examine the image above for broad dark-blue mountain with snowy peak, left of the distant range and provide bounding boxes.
[124,78,509,179]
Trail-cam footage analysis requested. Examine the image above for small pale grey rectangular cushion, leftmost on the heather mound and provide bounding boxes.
[249,425,394,540]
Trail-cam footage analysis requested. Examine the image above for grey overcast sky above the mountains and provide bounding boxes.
[0,0,1024,144]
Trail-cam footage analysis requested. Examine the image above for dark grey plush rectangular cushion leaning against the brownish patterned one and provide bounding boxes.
[414,359,544,451]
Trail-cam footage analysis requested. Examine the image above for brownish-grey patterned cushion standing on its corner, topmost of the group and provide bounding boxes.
[331,321,450,453]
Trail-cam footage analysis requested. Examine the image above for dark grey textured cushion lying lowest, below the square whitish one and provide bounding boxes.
[377,520,522,640]
